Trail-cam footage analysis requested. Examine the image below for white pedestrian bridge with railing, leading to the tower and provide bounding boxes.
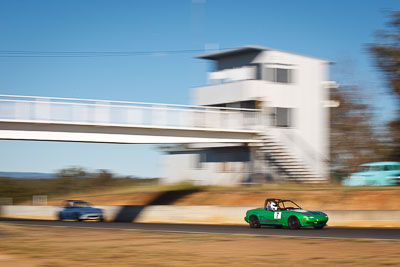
[0,95,264,144]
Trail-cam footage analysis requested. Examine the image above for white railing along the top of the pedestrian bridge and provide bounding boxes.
[0,95,263,131]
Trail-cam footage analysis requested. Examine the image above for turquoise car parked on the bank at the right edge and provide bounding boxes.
[342,161,400,186]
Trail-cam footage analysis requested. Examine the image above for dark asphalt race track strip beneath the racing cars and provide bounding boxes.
[0,218,400,241]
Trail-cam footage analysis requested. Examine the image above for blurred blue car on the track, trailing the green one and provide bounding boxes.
[58,200,104,221]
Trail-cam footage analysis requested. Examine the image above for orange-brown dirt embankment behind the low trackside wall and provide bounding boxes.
[49,189,400,210]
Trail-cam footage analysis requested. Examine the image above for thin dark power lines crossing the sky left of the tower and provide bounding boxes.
[0,49,223,57]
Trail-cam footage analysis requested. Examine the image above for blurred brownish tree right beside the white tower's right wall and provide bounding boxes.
[330,86,384,180]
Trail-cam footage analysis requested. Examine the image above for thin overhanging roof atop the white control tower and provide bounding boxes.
[196,45,332,63]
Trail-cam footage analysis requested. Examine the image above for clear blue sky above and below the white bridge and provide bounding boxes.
[0,0,400,177]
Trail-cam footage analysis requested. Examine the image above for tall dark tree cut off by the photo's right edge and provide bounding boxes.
[369,11,400,161]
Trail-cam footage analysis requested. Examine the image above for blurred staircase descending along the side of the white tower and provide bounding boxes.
[258,134,326,183]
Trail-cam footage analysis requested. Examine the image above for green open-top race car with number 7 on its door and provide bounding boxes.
[244,198,328,229]
